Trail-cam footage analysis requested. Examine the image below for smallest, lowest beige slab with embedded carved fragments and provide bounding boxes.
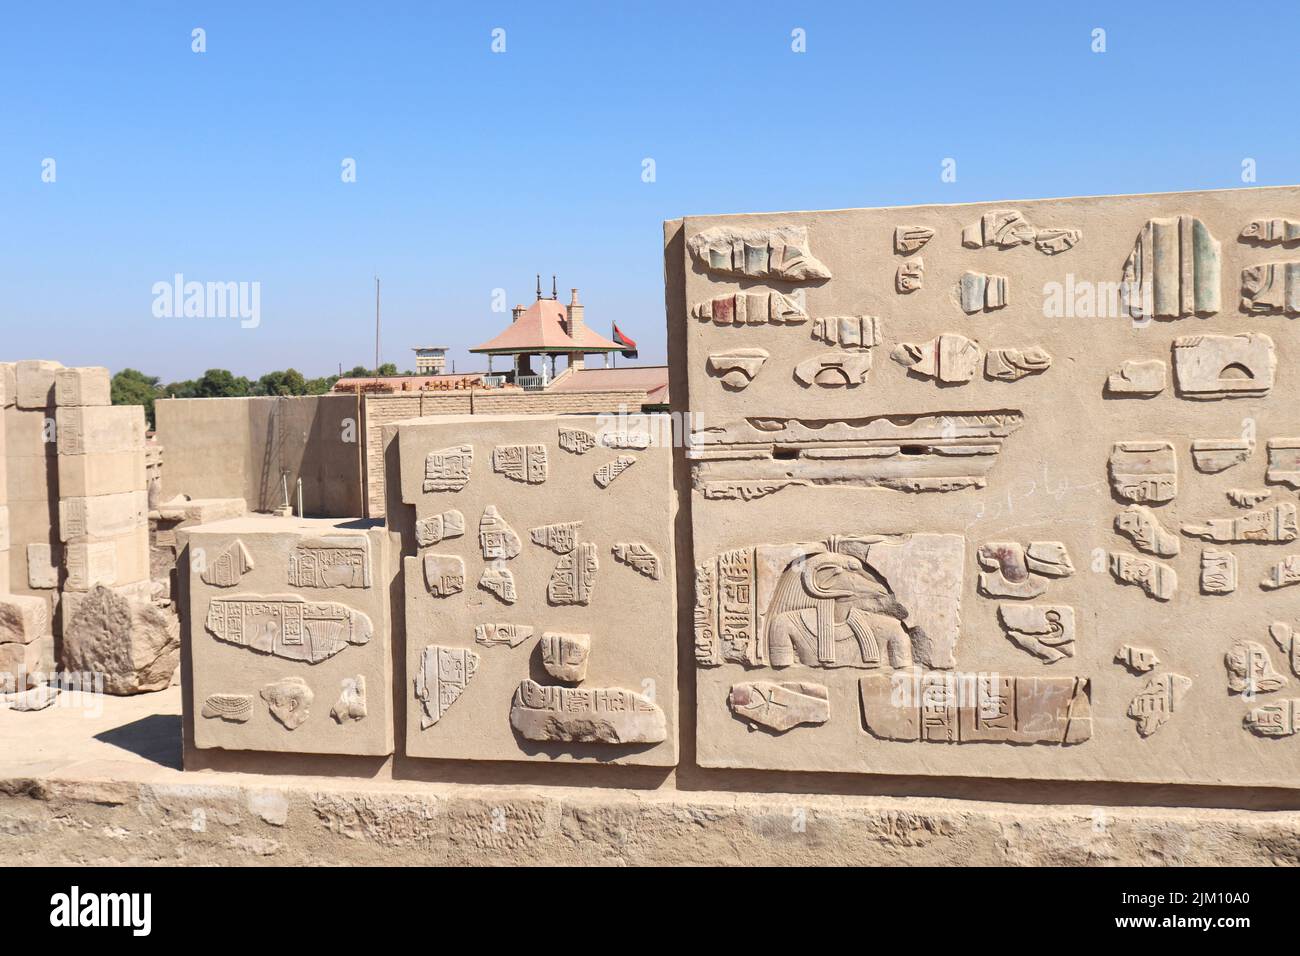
[178,515,390,756]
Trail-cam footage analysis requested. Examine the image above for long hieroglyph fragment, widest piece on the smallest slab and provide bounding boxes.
[204,594,373,663]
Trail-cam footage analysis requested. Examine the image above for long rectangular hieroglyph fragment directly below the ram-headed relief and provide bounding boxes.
[858,671,1092,744]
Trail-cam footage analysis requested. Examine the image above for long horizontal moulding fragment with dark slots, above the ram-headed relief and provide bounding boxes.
[686,411,1023,499]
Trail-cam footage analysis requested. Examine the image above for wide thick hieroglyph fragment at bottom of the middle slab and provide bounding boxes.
[510,680,668,744]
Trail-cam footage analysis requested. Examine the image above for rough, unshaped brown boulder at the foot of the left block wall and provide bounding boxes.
[62,587,181,696]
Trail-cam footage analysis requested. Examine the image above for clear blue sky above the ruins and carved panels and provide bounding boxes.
[0,0,1300,380]
